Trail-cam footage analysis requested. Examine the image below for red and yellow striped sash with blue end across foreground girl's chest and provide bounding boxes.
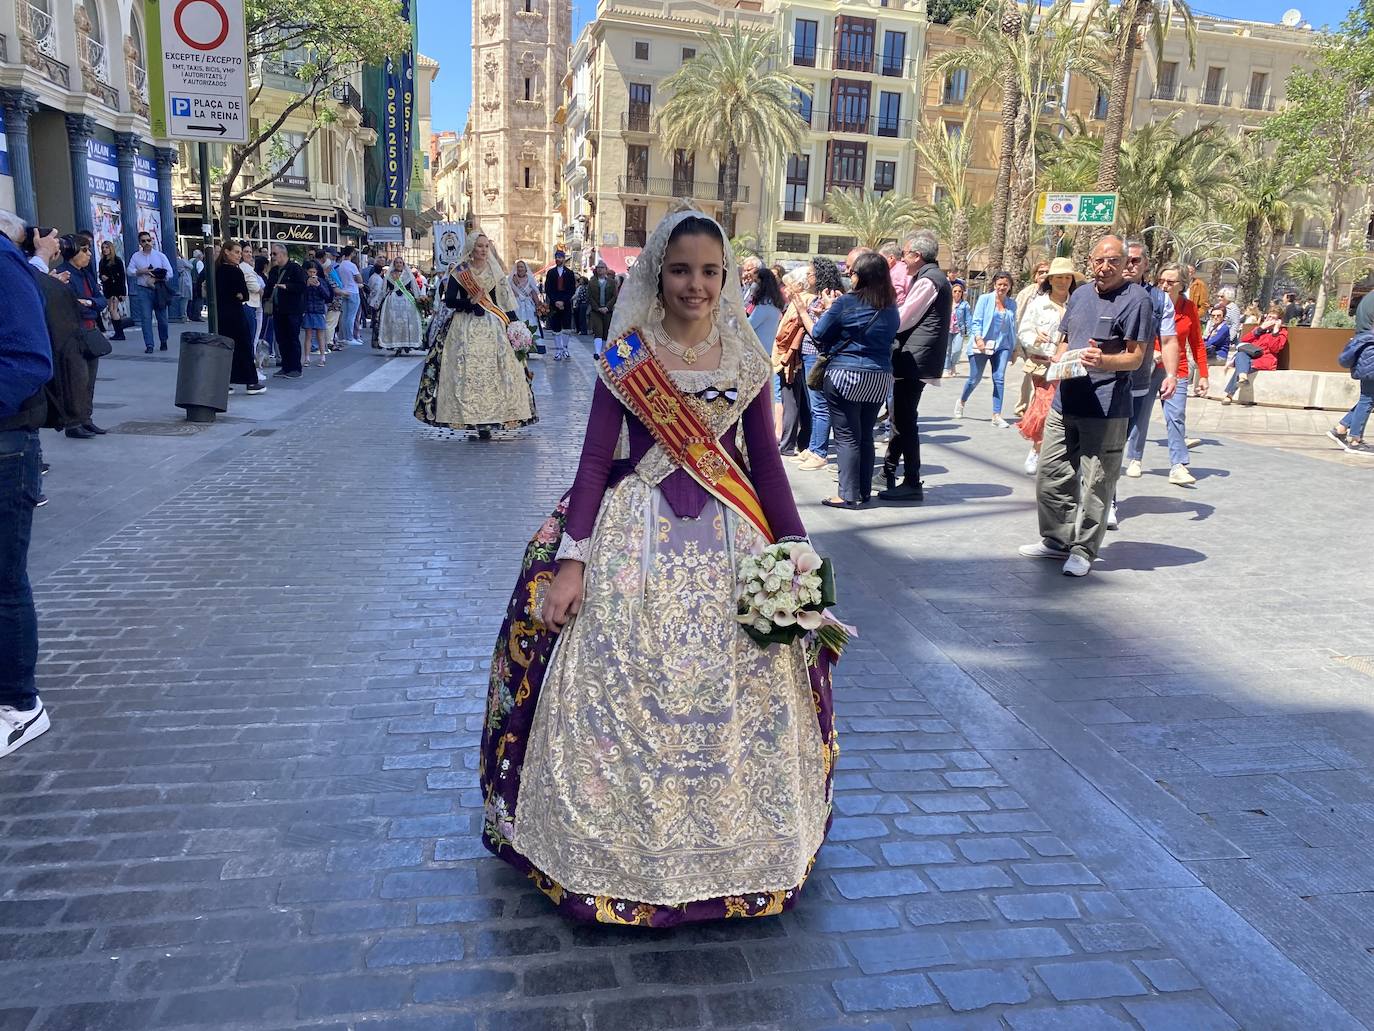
[596,329,774,544]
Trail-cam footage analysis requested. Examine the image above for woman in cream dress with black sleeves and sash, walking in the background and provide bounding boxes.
[415,232,539,440]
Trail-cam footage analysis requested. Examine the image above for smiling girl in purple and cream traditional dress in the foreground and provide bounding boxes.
[481,212,835,927]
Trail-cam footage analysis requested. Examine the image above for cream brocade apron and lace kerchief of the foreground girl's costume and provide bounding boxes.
[511,346,829,906]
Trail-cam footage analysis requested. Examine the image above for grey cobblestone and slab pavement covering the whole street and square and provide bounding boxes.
[0,335,1374,1031]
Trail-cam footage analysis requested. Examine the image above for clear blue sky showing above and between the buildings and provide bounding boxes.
[419,0,1349,132]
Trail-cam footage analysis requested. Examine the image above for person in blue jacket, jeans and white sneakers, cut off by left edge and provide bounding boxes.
[0,212,54,757]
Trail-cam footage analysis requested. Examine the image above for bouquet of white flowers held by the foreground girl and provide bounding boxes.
[735,540,855,657]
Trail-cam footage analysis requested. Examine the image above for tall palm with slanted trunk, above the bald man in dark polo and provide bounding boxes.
[1074,0,1197,258]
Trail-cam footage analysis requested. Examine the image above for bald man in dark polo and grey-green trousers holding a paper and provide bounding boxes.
[1020,236,1154,576]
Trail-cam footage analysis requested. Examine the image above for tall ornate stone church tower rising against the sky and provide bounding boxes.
[469,0,573,268]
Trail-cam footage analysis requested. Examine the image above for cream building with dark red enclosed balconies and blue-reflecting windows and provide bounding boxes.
[764,0,927,260]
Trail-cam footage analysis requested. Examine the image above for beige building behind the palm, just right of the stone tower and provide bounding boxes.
[561,0,775,267]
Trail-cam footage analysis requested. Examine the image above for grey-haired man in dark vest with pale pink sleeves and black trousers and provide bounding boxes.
[878,230,954,502]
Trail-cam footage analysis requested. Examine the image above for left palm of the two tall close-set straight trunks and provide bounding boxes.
[926,0,1031,268]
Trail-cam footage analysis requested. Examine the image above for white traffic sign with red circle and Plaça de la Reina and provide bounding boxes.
[143,0,249,143]
